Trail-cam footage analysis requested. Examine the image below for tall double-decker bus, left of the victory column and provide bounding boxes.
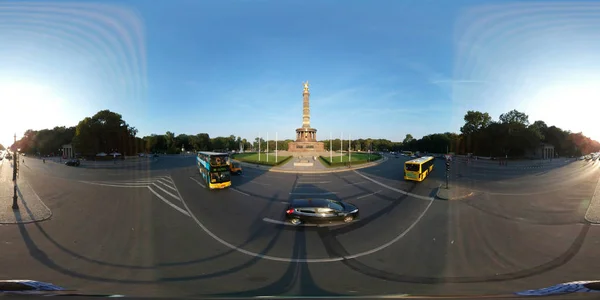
[196,152,231,190]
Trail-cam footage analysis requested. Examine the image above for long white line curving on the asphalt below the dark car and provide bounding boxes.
[173,171,434,263]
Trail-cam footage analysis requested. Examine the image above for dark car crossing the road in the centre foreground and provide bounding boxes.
[285,199,358,225]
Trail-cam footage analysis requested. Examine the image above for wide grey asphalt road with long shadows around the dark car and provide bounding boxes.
[0,157,600,297]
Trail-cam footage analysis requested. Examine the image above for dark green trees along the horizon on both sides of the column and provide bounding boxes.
[12,110,600,157]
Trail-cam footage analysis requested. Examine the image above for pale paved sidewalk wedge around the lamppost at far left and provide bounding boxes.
[0,160,52,224]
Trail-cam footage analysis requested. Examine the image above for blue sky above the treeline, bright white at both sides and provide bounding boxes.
[0,0,600,144]
